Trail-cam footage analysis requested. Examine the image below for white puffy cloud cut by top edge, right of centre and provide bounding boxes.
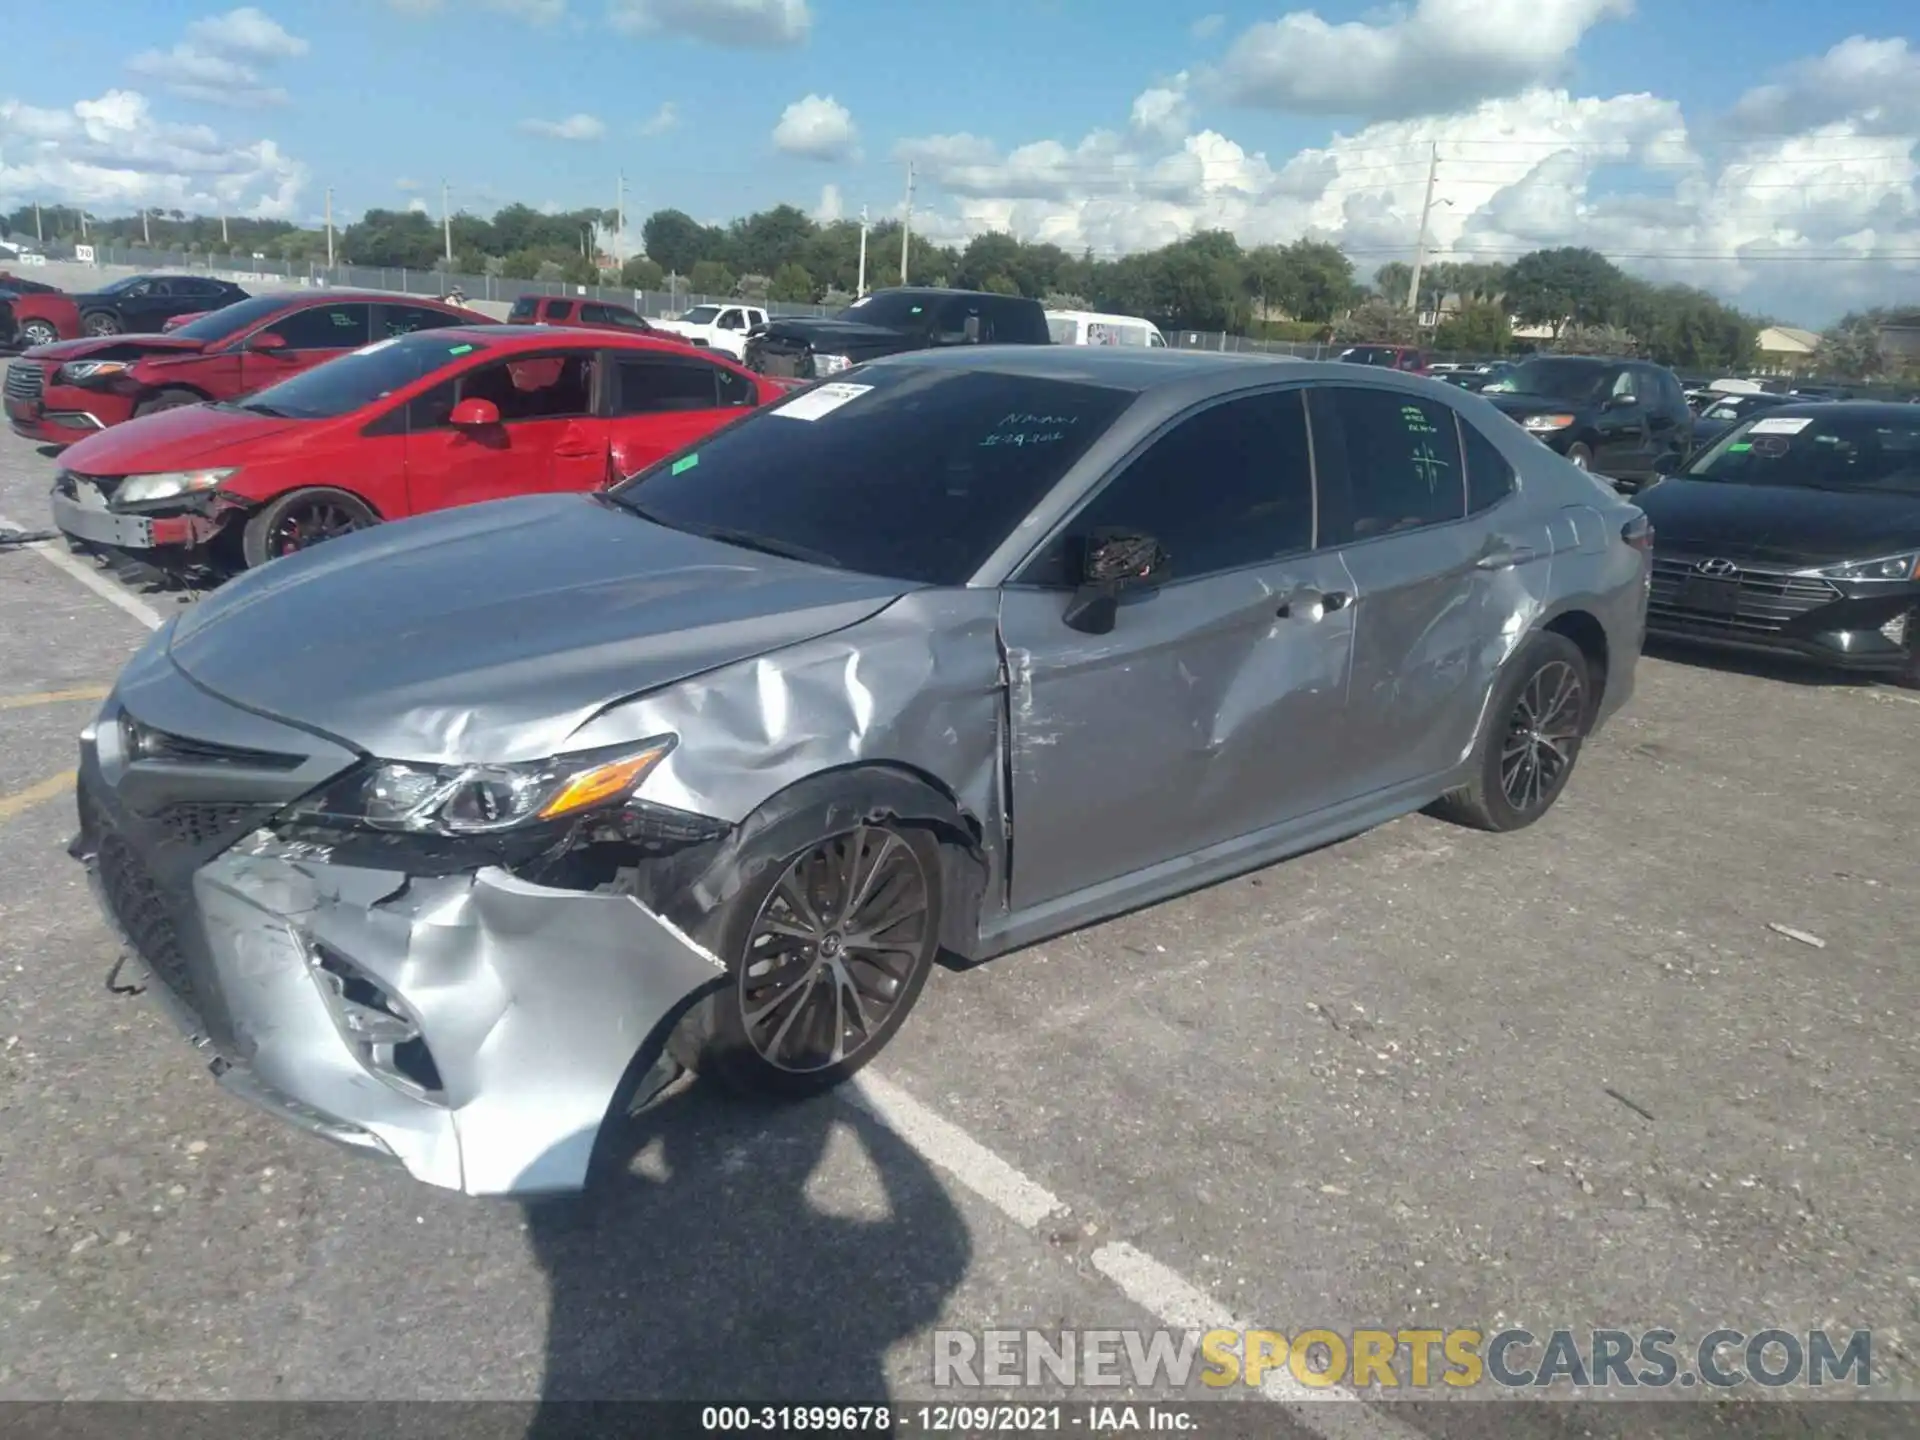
[1208,0,1634,119]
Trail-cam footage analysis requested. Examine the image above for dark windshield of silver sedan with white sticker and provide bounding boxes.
[612,367,1133,586]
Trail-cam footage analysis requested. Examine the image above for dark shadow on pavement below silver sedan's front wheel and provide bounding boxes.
[526,1083,972,1440]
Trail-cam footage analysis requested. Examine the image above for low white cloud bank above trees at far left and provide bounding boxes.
[0,90,307,219]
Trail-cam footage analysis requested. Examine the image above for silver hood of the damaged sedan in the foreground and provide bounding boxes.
[171,495,916,764]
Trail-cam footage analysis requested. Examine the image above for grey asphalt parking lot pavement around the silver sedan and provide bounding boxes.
[0,422,1920,1436]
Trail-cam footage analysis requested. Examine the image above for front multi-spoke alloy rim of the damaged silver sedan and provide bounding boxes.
[735,826,933,1073]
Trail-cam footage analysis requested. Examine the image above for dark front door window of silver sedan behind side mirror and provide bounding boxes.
[1033,390,1313,584]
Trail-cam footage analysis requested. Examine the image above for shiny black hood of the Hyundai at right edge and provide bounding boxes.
[1634,476,1920,566]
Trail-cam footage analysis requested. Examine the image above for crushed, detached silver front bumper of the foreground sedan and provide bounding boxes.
[71,662,724,1196]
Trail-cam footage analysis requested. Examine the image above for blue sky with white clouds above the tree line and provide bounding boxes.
[0,0,1920,323]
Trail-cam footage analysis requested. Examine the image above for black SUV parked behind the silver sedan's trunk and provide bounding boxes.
[1480,355,1693,493]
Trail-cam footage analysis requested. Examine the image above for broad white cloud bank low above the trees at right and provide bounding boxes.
[895,60,1920,323]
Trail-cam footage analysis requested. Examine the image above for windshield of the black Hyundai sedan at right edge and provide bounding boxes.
[1686,411,1920,495]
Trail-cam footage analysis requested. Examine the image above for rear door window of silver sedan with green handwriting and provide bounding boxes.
[1313,386,1467,543]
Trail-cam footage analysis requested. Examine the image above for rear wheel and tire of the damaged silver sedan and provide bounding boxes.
[1434,632,1594,831]
